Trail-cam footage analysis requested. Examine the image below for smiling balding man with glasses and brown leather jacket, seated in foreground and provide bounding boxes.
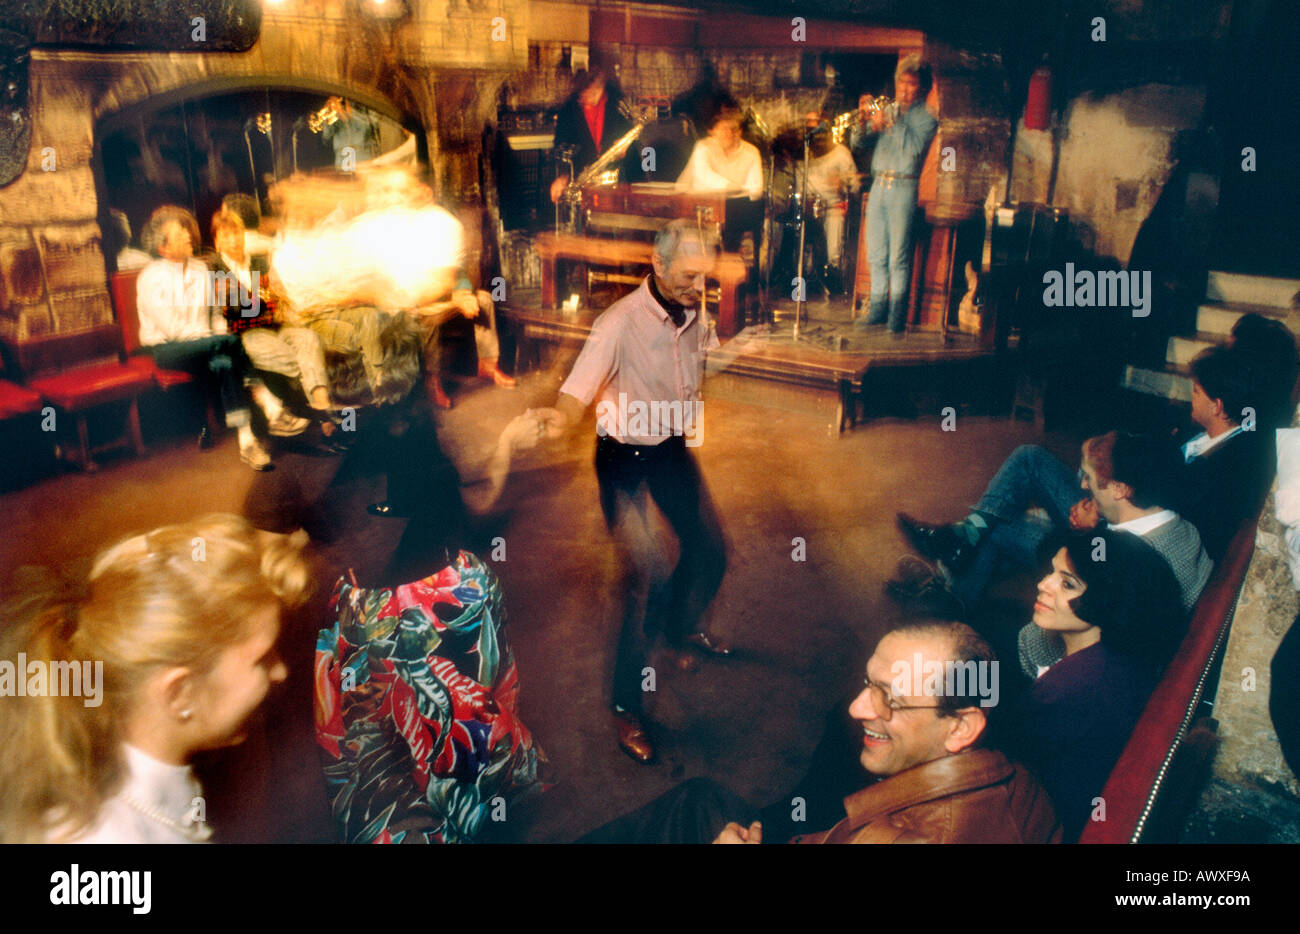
[584,620,1061,843]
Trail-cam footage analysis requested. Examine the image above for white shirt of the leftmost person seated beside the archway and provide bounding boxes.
[135,258,226,347]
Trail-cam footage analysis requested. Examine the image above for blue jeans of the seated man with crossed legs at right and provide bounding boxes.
[953,445,1087,609]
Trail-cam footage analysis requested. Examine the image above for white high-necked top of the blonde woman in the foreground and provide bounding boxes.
[48,743,203,843]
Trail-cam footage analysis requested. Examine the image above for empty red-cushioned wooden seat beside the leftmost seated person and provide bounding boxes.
[13,325,152,471]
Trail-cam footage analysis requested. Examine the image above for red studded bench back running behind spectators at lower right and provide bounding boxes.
[1079,520,1256,843]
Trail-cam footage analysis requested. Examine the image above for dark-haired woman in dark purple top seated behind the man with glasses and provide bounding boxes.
[1008,529,1186,842]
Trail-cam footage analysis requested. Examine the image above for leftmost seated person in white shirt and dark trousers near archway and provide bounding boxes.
[135,204,270,470]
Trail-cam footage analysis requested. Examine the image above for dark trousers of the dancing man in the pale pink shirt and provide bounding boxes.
[595,437,727,713]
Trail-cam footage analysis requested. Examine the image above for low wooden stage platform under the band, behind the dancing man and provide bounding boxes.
[498,297,993,432]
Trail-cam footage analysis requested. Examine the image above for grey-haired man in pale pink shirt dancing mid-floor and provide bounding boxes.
[534,220,731,764]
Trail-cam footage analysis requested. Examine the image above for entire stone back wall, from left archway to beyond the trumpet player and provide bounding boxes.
[0,0,1213,348]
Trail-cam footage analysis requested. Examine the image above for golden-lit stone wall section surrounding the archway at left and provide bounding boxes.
[0,0,529,341]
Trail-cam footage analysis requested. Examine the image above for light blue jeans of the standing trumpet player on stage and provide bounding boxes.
[867,178,917,333]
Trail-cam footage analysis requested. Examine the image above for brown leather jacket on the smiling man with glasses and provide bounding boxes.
[793,749,1061,843]
